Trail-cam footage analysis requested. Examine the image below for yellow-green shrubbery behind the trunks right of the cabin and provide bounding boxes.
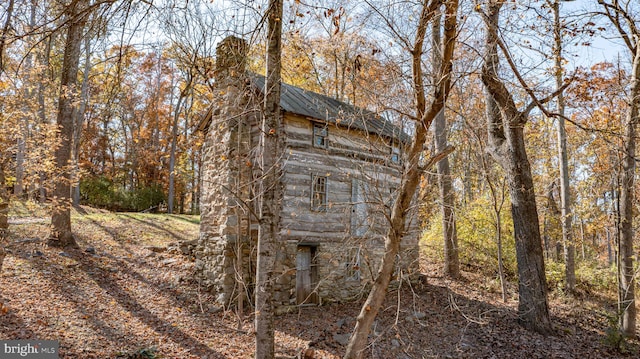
[421,196,517,277]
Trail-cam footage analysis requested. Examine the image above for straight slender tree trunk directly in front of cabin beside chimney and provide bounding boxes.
[255,0,283,359]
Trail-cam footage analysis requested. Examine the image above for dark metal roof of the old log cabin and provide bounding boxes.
[249,74,409,142]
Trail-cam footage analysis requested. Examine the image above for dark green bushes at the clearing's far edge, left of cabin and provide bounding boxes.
[80,176,165,212]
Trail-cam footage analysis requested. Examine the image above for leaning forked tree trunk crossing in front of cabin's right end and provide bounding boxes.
[344,0,458,359]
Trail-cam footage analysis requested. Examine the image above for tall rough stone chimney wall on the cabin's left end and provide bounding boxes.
[194,37,252,305]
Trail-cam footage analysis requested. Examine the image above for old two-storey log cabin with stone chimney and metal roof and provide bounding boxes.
[195,37,418,308]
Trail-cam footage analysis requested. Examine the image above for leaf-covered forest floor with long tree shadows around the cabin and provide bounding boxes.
[0,201,640,359]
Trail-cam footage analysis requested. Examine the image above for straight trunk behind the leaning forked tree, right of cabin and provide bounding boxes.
[432,8,460,278]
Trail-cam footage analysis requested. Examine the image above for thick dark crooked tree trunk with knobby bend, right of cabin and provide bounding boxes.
[482,0,552,334]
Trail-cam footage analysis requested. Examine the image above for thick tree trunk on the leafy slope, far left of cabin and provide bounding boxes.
[49,1,85,247]
